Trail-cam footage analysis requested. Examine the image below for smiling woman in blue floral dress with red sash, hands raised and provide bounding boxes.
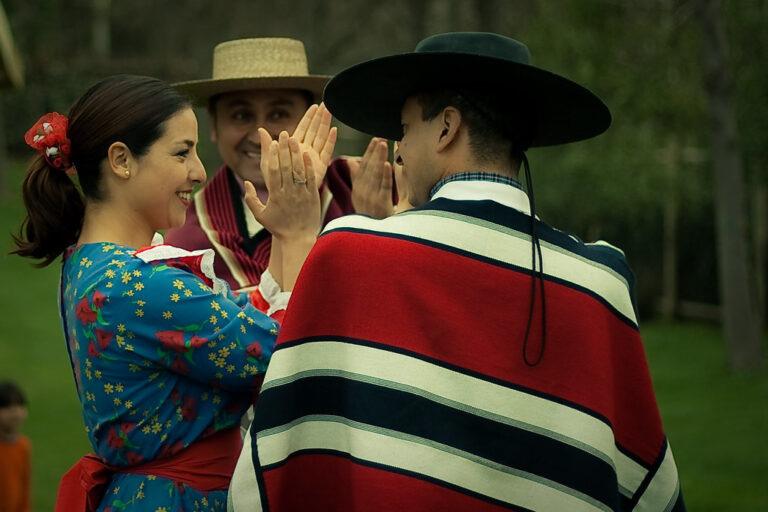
[16,76,333,512]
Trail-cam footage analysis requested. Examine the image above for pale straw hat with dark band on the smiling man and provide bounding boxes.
[172,37,331,106]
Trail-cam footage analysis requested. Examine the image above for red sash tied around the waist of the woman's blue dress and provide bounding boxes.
[54,427,242,512]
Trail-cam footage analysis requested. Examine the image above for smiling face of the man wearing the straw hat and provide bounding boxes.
[211,89,309,187]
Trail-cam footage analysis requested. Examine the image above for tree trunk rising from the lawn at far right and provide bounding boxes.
[699,0,762,370]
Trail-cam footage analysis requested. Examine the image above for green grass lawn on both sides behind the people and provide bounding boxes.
[0,163,768,512]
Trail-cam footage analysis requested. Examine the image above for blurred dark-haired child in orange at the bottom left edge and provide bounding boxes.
[0,382,32,512]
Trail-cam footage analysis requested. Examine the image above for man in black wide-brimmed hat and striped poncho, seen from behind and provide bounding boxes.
[230,33,685,512]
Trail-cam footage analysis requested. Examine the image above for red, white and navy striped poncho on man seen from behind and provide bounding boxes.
[229,174,685,512]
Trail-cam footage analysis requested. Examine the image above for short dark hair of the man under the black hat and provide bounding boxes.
[415,89,531,166]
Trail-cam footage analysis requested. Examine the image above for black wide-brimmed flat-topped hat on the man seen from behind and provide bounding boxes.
[323,32,611,147]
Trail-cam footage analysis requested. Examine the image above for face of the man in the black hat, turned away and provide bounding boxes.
[396,96,441,206]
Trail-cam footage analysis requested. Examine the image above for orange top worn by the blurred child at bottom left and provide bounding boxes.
[0,435,32,512]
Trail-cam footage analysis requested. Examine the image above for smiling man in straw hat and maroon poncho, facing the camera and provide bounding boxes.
[165,38,391,289]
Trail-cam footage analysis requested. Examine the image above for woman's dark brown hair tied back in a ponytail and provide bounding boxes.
[12,75,190,267]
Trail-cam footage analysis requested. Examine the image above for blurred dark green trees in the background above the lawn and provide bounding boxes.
[0,0,768,508]
